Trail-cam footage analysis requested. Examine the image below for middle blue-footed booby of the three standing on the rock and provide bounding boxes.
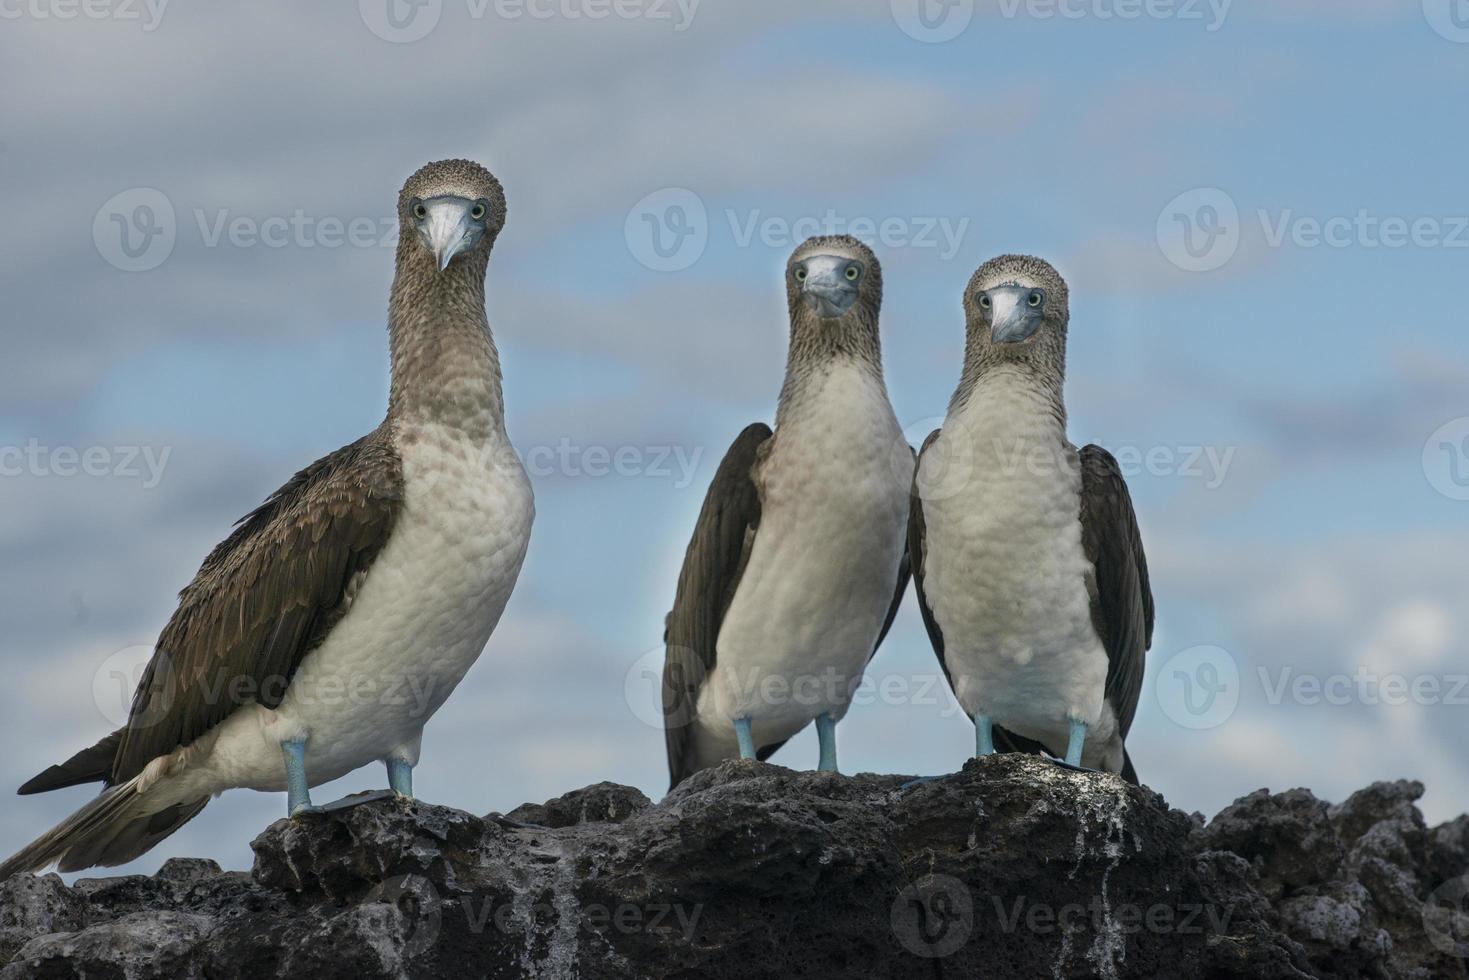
[663,235,914,786]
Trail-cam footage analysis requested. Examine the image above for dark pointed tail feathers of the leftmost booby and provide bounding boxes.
[0,779,209,882]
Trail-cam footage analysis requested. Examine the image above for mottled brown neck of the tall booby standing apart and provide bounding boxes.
[388,256,505,442]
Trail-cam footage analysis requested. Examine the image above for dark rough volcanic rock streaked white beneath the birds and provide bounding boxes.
[0,755,1469,980]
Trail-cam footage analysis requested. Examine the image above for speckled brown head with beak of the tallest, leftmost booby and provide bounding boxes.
[398,160,505,272]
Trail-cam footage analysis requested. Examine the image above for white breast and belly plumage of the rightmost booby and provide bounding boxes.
[918,375,1115,760]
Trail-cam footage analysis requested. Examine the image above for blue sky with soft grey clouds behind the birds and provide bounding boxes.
[0,0,1469,873]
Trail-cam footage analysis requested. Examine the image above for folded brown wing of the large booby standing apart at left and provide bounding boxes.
[22,430,403,792]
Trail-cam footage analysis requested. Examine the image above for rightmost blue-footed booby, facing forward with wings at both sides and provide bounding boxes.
[908,256,1153,783]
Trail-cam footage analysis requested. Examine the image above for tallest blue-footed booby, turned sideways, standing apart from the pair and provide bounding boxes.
[0,160,535,880]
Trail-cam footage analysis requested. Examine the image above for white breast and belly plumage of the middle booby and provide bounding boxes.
[698,366,912,758]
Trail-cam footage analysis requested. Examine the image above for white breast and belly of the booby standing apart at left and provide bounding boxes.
[192,426,535,792]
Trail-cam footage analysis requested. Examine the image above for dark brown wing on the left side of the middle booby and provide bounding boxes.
[663,422,771,788]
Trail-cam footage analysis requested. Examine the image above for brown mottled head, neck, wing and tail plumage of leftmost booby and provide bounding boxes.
[0,160,517,880]
